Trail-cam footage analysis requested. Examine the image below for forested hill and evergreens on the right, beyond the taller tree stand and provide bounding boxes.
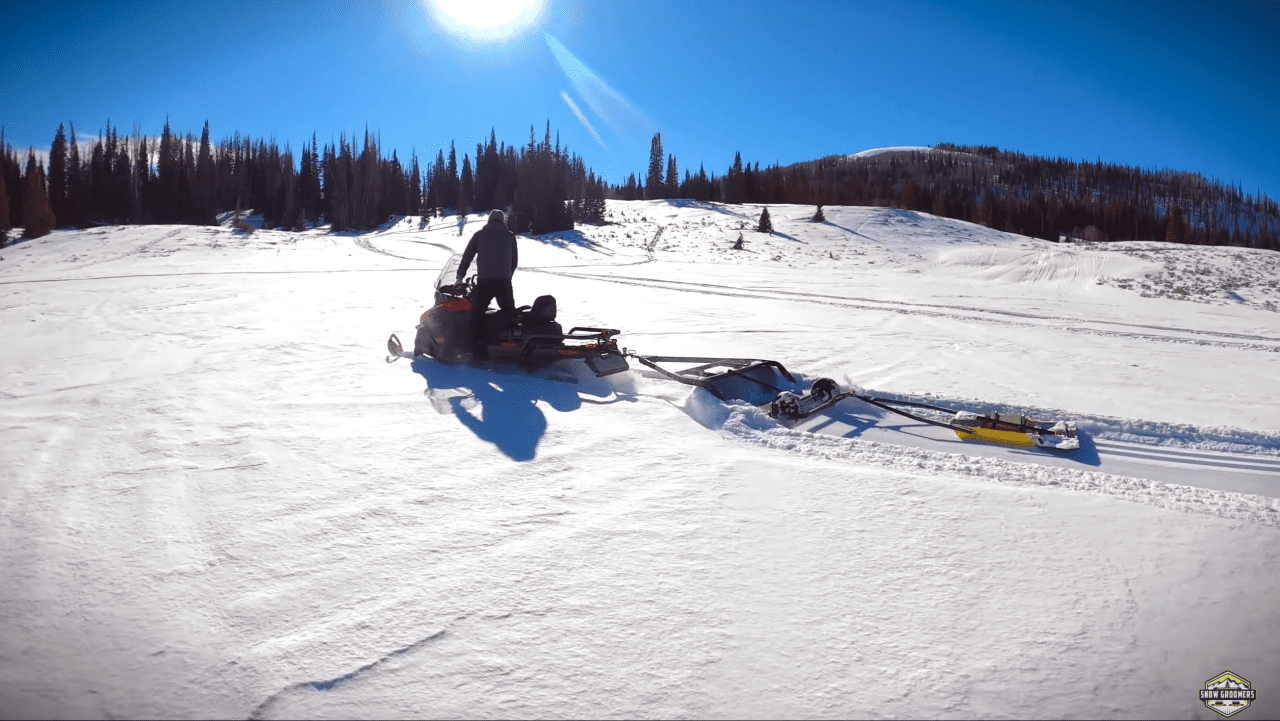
[607,133,1280,251]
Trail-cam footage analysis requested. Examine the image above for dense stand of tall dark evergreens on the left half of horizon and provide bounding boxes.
[0,122,605,242]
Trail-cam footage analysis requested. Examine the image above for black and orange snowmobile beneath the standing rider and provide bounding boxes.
[387,255,630,377]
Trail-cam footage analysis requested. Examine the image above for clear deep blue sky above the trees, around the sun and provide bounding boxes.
[0,0,1280,198]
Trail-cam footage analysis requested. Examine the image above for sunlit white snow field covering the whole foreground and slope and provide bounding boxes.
[0,201,1280,718]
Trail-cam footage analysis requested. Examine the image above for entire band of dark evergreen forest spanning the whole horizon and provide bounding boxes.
[0,122,1280,251]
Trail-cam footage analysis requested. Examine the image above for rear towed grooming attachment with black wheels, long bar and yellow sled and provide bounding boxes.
[762,378,1080,451]
